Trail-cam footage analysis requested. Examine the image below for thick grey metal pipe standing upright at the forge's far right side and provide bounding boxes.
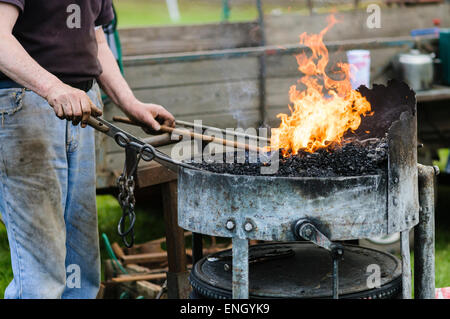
[414,165,436,299]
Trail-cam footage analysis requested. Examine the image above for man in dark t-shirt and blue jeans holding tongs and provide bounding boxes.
[0,0,174,298]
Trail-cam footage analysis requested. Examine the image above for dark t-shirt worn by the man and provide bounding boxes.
[0,0,114,84]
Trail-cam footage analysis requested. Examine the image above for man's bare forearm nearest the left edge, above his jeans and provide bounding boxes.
[0,32,61,98]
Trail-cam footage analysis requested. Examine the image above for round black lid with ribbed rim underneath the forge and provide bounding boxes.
[190,242,401,298]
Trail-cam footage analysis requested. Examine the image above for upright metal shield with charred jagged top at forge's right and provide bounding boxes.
[356,80,419,234]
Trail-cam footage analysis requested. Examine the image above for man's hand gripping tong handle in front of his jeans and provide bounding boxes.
[45,82,102,127]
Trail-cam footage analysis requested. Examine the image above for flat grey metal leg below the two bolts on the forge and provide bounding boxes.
[232,237,249,299]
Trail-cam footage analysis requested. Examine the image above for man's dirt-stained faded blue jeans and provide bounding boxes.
[0,84,101,298]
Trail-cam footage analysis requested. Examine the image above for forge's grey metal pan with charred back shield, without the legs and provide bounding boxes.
[179,82,419,241]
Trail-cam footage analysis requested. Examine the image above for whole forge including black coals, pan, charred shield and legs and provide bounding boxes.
[178,81,435,298]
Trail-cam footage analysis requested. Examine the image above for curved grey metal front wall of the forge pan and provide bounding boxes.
[178,168,387,241]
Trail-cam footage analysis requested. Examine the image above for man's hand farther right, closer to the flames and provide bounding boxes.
[126,100,175,133]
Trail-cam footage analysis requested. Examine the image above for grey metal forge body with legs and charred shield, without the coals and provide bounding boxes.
[178,81,434,298]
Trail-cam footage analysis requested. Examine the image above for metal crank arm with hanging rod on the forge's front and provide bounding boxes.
[294,219,344,299]
